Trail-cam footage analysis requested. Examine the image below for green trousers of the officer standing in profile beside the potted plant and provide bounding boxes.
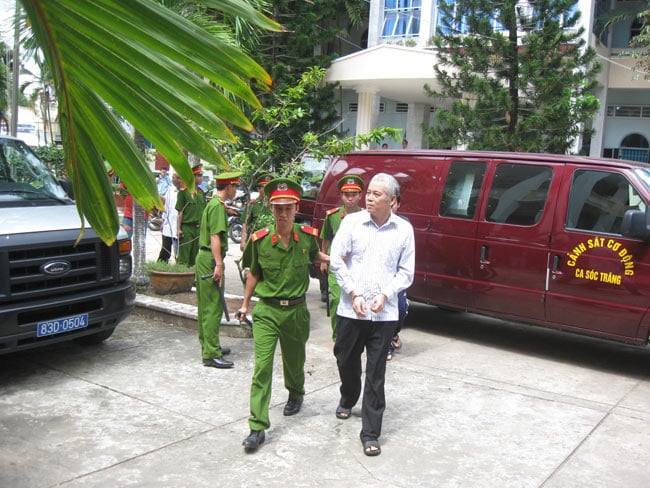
[196,250,223,359]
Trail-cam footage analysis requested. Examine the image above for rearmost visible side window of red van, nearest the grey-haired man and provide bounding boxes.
[440,162,486,219]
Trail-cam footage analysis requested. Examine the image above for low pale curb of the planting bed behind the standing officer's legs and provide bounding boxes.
[134,293,253,339]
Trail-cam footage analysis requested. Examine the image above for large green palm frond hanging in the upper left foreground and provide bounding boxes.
[22,0,274,243]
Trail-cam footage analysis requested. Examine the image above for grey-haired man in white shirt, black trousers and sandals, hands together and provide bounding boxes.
[330,173,415,456]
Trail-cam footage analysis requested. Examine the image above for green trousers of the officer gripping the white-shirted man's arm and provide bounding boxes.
[248,300,310,430]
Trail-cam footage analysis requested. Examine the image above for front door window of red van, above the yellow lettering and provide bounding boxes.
[566,169,646,235]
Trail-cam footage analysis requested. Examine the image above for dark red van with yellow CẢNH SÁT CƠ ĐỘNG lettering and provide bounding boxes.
[313,150,650,344]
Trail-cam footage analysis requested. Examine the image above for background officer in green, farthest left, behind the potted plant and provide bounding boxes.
[175,166,206,266]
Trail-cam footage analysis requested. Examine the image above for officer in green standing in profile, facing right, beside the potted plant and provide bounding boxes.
[196,171,241,369]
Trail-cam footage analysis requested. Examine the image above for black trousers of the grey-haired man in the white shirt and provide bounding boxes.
[334,315,397,441]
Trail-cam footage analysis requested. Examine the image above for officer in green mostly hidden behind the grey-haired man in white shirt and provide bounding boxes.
[320,175,364,341]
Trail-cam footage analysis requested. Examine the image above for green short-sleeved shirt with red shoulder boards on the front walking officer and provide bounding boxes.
[247,224,318,298]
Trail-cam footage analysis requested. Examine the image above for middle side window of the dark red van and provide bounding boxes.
[485,164,553,225]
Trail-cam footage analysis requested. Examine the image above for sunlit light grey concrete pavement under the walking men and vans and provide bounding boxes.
[0,231,650,487]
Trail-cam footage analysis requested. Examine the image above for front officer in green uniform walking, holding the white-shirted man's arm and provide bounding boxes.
[237,178,329,452]
